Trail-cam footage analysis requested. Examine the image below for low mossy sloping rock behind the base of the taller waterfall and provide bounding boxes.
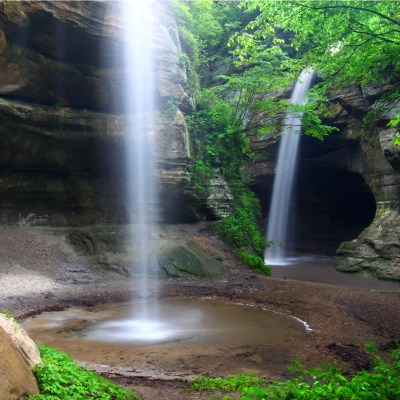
[68,225,227,278]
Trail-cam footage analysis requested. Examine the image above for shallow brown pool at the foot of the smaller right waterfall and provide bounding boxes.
[271,255,400,290]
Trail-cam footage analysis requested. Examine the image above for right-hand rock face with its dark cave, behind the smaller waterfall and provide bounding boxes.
[249,83,400,279]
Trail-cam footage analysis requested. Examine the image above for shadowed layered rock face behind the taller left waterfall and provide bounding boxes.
[0,1,196,226]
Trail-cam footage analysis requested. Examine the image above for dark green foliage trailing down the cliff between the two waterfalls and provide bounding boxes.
[187,90,265,262]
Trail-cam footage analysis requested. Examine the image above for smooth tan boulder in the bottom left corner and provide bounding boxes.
[0,315,40,400]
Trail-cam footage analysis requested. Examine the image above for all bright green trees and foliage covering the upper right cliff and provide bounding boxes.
[174,0,400,268]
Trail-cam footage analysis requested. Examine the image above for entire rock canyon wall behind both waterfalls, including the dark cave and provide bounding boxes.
[0,1,400,279]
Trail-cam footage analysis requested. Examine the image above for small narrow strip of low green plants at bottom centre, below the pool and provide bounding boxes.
[189,374,266,392]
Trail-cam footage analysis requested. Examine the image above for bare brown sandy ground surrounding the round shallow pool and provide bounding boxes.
[0,226,400,400]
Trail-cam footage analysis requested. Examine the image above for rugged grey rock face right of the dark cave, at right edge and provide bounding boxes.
[334,88,400,280]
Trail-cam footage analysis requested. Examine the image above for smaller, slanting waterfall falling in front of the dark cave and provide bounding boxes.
[264,71,313,265]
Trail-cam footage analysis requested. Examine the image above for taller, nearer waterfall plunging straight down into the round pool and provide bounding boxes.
[122,0,158,321]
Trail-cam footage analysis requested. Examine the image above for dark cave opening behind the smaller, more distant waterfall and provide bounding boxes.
[251,148,376,256]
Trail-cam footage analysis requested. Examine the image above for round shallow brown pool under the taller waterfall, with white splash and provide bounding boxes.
[24,299,307,378]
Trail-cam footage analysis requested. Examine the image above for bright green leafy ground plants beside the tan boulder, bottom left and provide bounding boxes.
[28,345,139,400]
